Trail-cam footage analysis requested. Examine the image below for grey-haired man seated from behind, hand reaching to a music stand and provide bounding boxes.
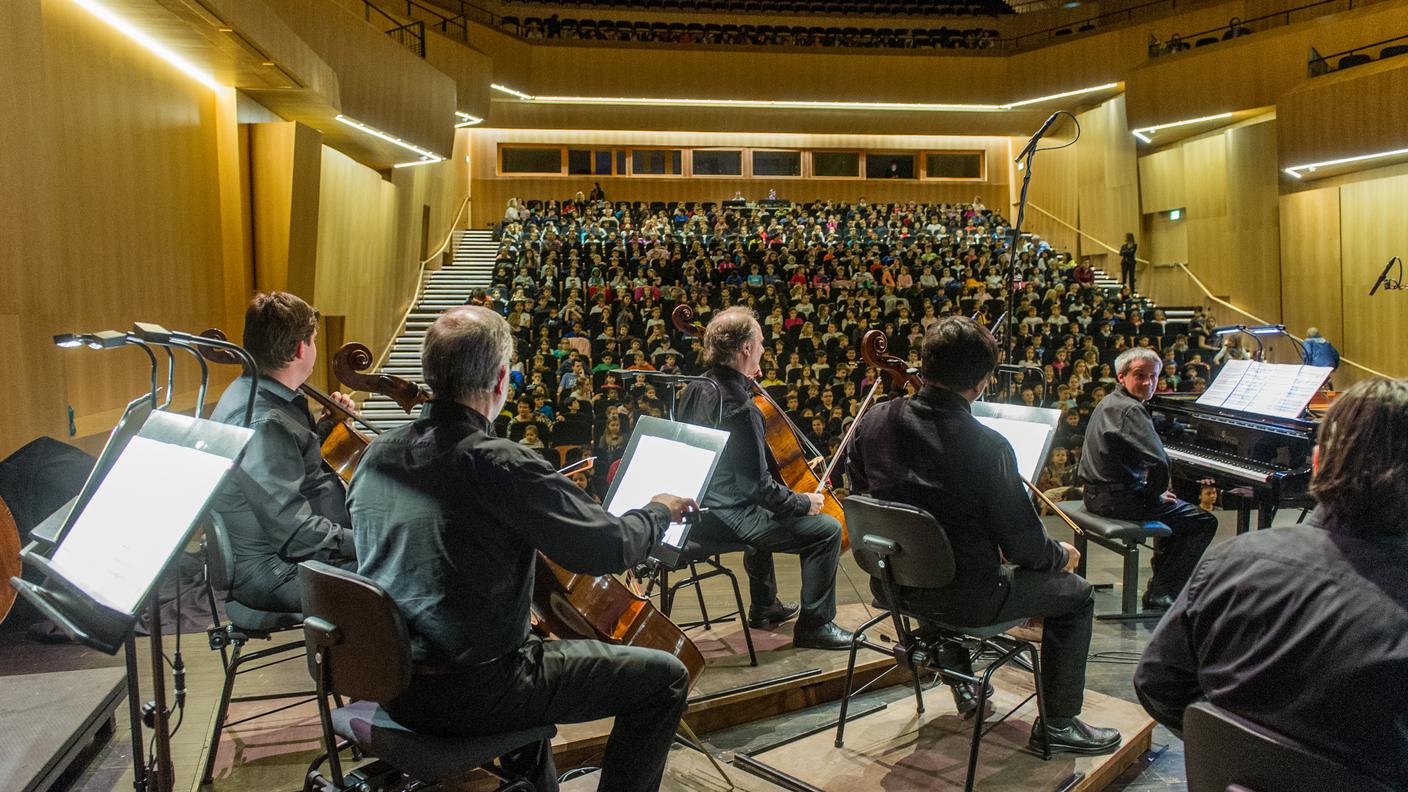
[348,306,693,792]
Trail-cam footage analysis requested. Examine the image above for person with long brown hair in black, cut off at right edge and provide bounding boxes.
[1135,378,1408,789]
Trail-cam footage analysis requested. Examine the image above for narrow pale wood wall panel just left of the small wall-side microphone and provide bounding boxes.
[1280,187,1345,345]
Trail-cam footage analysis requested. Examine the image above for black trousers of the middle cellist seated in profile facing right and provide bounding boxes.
[694,506,841,627]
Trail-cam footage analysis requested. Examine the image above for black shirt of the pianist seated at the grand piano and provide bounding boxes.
[1080,386,1169,505]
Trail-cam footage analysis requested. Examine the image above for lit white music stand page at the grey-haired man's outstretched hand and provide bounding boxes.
[605,416,728,564]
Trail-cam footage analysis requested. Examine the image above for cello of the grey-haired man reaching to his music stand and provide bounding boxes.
[332,360,704,688]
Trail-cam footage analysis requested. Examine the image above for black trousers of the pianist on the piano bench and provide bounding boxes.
[1086,488,1218,596]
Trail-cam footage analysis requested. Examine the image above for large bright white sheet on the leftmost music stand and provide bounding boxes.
[51,437,231,613]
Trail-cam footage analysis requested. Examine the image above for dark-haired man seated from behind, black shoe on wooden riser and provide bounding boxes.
[849,317,1119,754]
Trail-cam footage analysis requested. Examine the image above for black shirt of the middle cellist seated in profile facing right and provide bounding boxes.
[676,366,811,517]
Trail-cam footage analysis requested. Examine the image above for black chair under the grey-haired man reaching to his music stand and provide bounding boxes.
[298,561,556,792]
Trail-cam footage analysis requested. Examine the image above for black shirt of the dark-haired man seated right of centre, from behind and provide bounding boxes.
[848,386,1066,589]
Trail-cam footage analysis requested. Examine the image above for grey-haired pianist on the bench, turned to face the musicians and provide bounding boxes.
[1080,347,1218,610]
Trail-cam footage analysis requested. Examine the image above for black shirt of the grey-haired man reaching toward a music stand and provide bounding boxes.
[348,400,670,668]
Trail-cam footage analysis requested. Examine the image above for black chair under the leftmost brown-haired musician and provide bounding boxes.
[200,512,313,784]
